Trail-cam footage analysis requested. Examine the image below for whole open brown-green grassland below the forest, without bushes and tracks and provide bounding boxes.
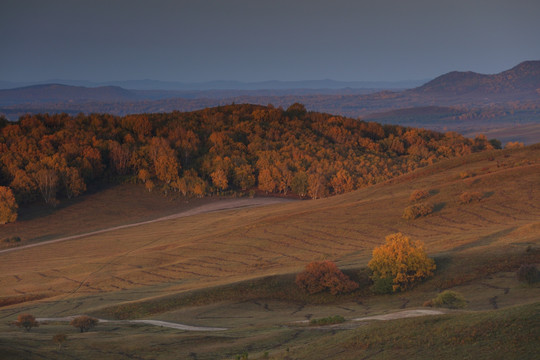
[0,146,540,359]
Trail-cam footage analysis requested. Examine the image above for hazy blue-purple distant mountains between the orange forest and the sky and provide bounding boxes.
[0,61,540,143]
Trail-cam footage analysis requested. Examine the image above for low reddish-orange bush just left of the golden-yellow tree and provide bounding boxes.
[296,260,358,295]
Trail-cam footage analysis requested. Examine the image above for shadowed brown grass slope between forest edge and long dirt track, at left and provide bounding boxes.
[0,184,217,247]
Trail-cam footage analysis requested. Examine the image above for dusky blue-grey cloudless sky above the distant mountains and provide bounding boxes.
[0,0,540,82]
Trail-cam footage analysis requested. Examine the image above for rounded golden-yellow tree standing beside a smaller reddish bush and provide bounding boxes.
[368,233,435,291]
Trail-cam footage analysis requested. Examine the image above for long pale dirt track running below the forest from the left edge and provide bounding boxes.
[0,198,294,254]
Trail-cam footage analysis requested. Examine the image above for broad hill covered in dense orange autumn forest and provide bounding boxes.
[0,104,492,217]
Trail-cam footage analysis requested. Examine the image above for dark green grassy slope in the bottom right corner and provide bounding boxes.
[286,303,540,360]
